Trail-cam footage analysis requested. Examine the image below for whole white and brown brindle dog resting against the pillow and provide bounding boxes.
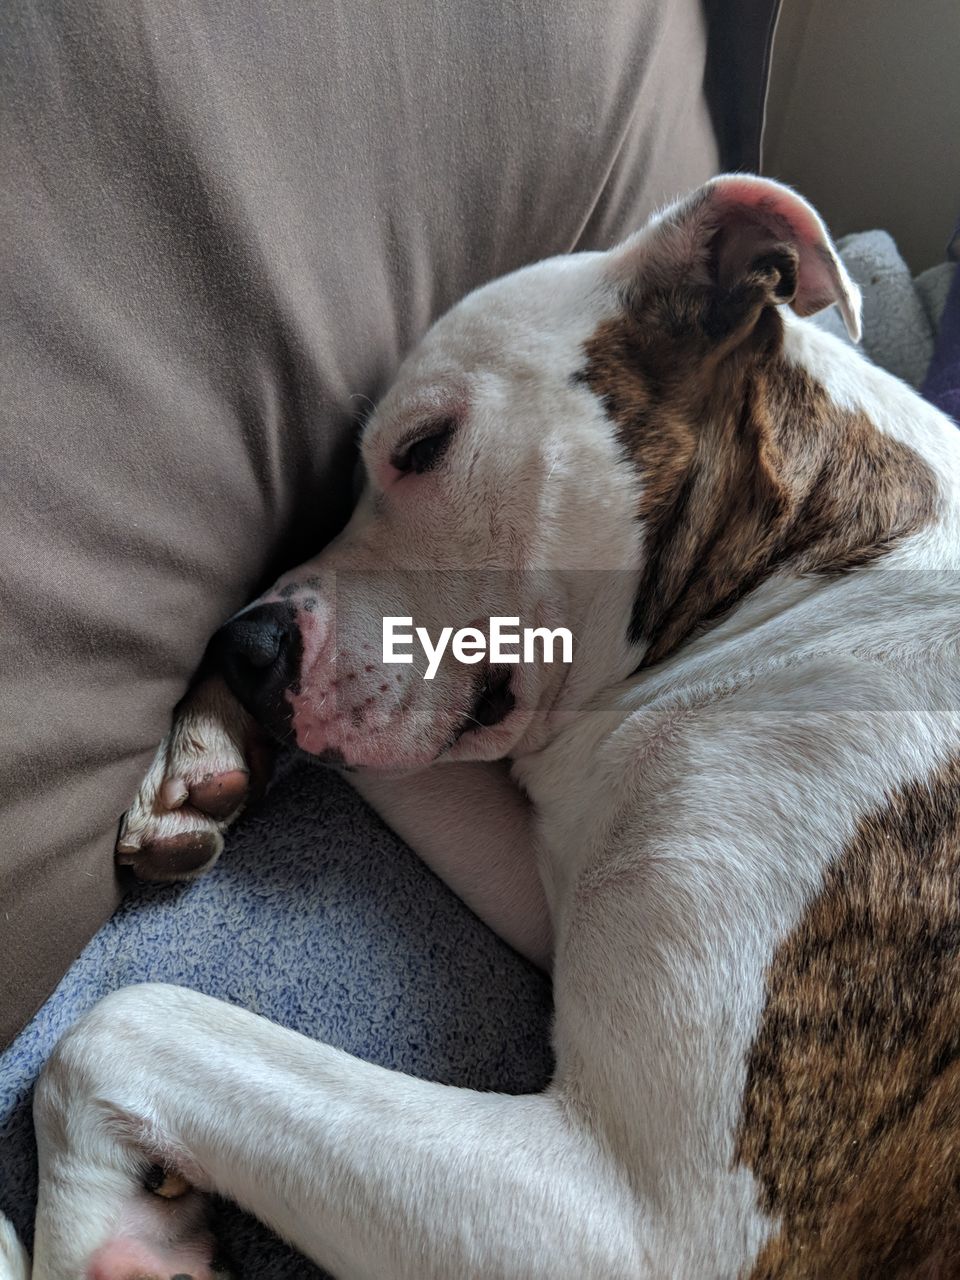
[0,177,960,1280]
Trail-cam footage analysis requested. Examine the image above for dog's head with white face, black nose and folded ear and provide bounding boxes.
[216,177,859,767]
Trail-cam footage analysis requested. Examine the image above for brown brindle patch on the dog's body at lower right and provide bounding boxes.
[737,758,960,1280]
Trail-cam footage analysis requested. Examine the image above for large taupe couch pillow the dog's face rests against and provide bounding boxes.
[0,0,773,1043]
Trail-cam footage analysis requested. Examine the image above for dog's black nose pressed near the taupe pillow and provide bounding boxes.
[210,604,301,731]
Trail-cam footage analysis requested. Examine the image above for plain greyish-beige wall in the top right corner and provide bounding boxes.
[764,0,960,271]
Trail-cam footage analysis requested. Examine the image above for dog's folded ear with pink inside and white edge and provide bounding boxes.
[611,174,860,340]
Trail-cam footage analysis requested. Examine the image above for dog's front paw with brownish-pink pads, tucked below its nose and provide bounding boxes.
[116,678,271,881]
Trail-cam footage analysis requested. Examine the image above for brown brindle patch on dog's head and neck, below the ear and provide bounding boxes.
[577,294,937,664]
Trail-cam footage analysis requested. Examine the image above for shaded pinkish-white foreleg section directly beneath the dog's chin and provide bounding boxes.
[349,763,553,969]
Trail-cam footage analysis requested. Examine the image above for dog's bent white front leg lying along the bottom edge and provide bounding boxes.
[24,986,640,1280]
